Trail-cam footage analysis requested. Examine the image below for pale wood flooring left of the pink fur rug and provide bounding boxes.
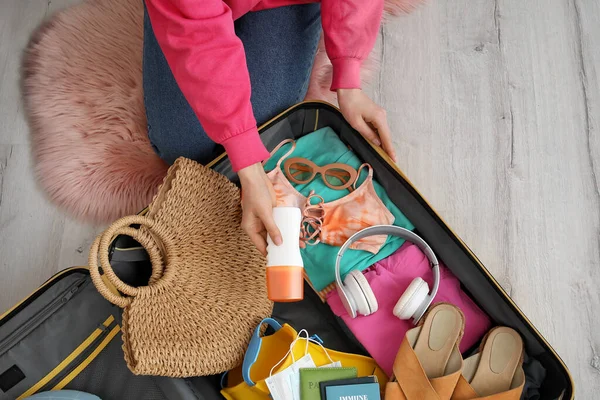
[0,0,98,311]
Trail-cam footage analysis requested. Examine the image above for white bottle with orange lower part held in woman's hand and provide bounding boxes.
[267,207,304,302]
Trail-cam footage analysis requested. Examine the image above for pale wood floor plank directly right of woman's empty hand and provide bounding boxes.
[381,1,510,290]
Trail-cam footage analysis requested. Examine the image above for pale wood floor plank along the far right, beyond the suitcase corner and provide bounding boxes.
[497,0,600,398]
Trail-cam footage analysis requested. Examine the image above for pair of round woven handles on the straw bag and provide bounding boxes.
[89,215,176,308]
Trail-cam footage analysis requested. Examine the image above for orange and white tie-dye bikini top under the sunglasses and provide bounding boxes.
[267,139,394,254]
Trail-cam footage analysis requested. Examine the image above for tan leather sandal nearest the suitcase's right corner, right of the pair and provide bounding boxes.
[452,327,525,400]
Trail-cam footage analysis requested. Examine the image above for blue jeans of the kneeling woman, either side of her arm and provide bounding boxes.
[143,3,321,164]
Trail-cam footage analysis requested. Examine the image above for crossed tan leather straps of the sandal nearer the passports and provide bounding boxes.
[385,337,461,400]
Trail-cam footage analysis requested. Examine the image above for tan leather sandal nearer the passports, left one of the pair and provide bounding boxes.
[385,303,465,400]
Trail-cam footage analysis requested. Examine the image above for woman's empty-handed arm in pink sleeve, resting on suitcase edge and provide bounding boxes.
[321,0,396,161]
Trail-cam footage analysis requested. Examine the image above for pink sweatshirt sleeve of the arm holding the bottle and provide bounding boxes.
[146,0,269,171]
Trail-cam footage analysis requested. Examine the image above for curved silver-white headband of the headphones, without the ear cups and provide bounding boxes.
[335,225,440,323]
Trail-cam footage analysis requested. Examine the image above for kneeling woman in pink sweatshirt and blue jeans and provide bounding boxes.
[143,0,395,254]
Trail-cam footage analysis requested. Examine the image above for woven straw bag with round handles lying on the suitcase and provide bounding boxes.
[89,158,273,377]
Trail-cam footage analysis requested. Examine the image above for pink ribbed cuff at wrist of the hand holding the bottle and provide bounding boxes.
[221,128,270,172]
